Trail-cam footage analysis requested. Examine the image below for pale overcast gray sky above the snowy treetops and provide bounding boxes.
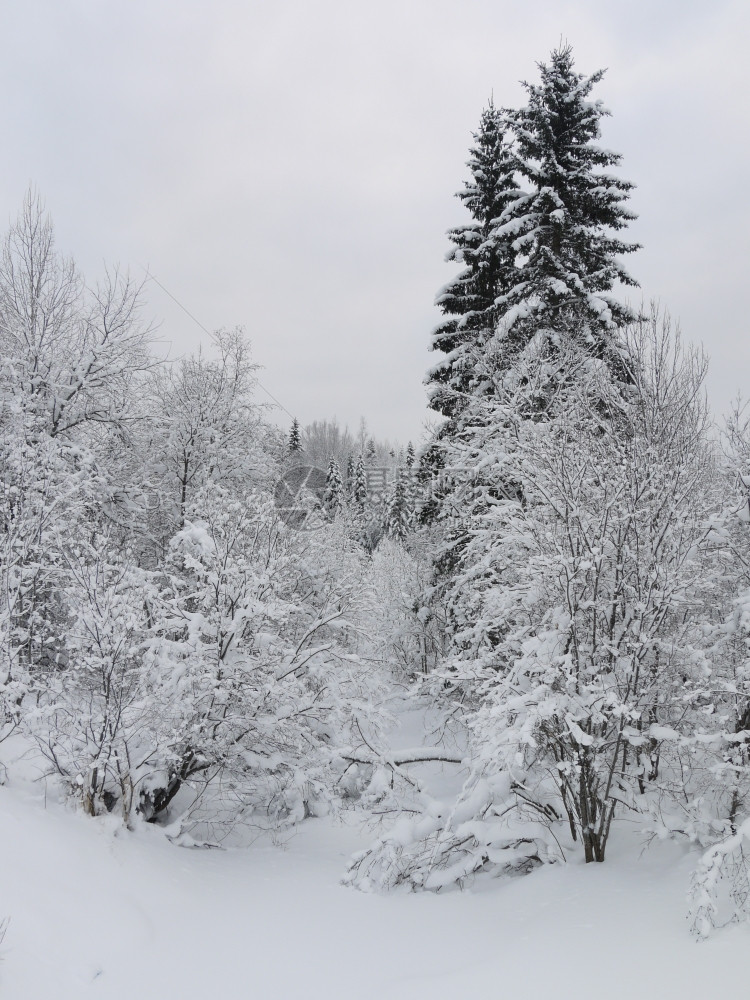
[0,0,750,441]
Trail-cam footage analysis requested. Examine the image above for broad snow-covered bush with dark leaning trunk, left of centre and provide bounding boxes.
[140,485,390,836]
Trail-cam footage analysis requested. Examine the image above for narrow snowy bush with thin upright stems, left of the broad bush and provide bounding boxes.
[26,538,158,823]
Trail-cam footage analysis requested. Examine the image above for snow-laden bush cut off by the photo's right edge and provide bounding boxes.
[680,402,750,937]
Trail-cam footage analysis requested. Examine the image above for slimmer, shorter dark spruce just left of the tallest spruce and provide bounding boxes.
[426,101,518,417]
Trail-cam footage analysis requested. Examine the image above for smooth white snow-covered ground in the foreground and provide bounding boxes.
[0,785,750,1000]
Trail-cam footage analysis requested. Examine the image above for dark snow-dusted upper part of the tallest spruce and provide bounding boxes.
[494,45,637,374]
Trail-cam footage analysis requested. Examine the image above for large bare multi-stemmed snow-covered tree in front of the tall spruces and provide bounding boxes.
[350,314,716,889]
